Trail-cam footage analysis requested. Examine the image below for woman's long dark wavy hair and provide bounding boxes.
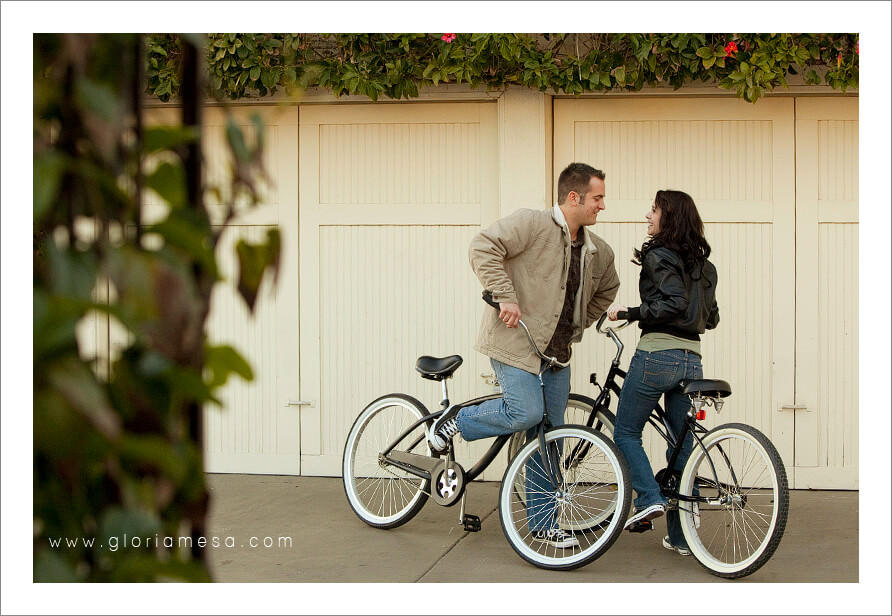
[635,190,712,271]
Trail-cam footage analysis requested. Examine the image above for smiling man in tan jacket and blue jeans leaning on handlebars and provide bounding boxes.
[430,163,619,548]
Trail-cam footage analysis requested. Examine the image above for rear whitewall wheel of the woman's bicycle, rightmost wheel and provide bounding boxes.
[679,424,790,578]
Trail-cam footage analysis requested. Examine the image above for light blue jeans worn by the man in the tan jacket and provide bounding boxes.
[456,359,570,531]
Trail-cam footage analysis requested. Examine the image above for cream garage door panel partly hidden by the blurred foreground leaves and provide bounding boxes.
[202,106,300,475]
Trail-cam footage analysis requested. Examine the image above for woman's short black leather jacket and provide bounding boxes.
[628,246,719,340]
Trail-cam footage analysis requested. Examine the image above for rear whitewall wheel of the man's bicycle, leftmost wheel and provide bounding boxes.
[343,394,431,528]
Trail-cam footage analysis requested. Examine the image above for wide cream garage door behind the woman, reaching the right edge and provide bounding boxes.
[555,98,858,488]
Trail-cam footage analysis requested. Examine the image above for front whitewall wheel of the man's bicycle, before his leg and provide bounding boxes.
[499,425,632,570]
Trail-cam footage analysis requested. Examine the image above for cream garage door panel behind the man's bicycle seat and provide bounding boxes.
[295,103,498,477]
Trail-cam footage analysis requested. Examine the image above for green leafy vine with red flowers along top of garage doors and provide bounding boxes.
[147,33,858,102]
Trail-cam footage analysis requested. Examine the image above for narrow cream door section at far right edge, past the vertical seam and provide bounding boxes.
[794,98,859,488]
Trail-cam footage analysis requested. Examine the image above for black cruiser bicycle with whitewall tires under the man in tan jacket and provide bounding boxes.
[343,296,632,570]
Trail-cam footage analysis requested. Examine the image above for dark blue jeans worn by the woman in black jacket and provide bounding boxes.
[613,349,703,547]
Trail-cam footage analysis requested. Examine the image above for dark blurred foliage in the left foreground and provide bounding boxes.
[33,34,279,582]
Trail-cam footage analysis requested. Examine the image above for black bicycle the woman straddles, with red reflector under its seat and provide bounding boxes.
[509,315,790,578]
